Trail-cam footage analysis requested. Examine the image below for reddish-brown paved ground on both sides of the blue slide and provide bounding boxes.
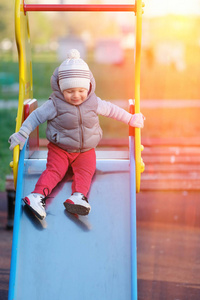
[0,191,200,300]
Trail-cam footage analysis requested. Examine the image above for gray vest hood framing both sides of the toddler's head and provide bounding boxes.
[50,68,96,99]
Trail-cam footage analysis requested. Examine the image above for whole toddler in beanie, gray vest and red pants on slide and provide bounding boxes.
[9,49,144,219]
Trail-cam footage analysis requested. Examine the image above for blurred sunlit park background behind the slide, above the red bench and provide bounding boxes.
[0,0,200,190]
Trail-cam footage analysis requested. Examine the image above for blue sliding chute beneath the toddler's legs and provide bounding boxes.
[8,138,137,300]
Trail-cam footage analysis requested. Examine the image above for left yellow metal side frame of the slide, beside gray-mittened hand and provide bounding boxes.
[10,0,33,187]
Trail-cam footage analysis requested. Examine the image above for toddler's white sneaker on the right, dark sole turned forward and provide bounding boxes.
[63,192,91,216]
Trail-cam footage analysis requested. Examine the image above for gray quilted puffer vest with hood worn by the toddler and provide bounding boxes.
[46,69,102,152]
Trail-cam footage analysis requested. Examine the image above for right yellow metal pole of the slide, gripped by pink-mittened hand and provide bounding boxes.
[135,0,145,193]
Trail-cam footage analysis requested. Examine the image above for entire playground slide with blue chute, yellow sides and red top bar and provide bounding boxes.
[9,0,144,300]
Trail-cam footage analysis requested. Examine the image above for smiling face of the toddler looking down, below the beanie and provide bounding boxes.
[63,88,88,105]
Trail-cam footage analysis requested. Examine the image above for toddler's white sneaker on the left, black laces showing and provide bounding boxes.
[23,193,46,220]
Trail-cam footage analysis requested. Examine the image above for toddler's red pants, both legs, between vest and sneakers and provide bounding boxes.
[33,143,96,197]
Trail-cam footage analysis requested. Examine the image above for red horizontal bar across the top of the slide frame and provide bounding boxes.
[24,3,135,13]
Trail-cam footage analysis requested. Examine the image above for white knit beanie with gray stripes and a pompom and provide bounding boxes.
[58,49,90,92]
